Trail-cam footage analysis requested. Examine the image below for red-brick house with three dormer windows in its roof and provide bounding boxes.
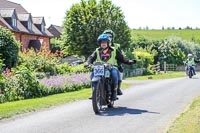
[0,0,53,51]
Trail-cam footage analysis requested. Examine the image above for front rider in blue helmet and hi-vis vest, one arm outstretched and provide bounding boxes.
[84,34,136,100]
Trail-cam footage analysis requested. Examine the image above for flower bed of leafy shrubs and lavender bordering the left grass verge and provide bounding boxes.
[0,66,90,103]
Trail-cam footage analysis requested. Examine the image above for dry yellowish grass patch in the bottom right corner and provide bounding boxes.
[167,97,200,133]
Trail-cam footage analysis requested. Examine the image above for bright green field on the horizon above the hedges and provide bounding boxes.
[131,30,200,43]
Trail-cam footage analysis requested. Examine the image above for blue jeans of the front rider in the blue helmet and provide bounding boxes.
[90,67,120,88]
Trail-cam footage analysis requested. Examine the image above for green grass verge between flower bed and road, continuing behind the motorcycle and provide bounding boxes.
[0,83,131,120]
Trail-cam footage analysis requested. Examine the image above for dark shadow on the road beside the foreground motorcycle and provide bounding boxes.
[99,107,160,116]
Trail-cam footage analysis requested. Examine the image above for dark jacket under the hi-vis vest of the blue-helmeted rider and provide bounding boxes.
[87,47,131,65]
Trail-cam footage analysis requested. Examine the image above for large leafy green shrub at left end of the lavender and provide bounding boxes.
[0,66,48,103]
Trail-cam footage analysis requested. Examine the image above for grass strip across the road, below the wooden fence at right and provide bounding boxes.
[126,72,185,80]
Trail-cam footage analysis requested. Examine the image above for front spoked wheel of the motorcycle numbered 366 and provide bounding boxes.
[92,81,102,114]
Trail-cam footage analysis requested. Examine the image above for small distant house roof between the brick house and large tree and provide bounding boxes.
[48,24,63,38]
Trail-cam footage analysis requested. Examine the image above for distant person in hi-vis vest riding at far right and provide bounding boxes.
[184,54,199,75]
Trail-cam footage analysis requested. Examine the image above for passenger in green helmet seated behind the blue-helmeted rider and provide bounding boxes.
[103,30,123,95]
